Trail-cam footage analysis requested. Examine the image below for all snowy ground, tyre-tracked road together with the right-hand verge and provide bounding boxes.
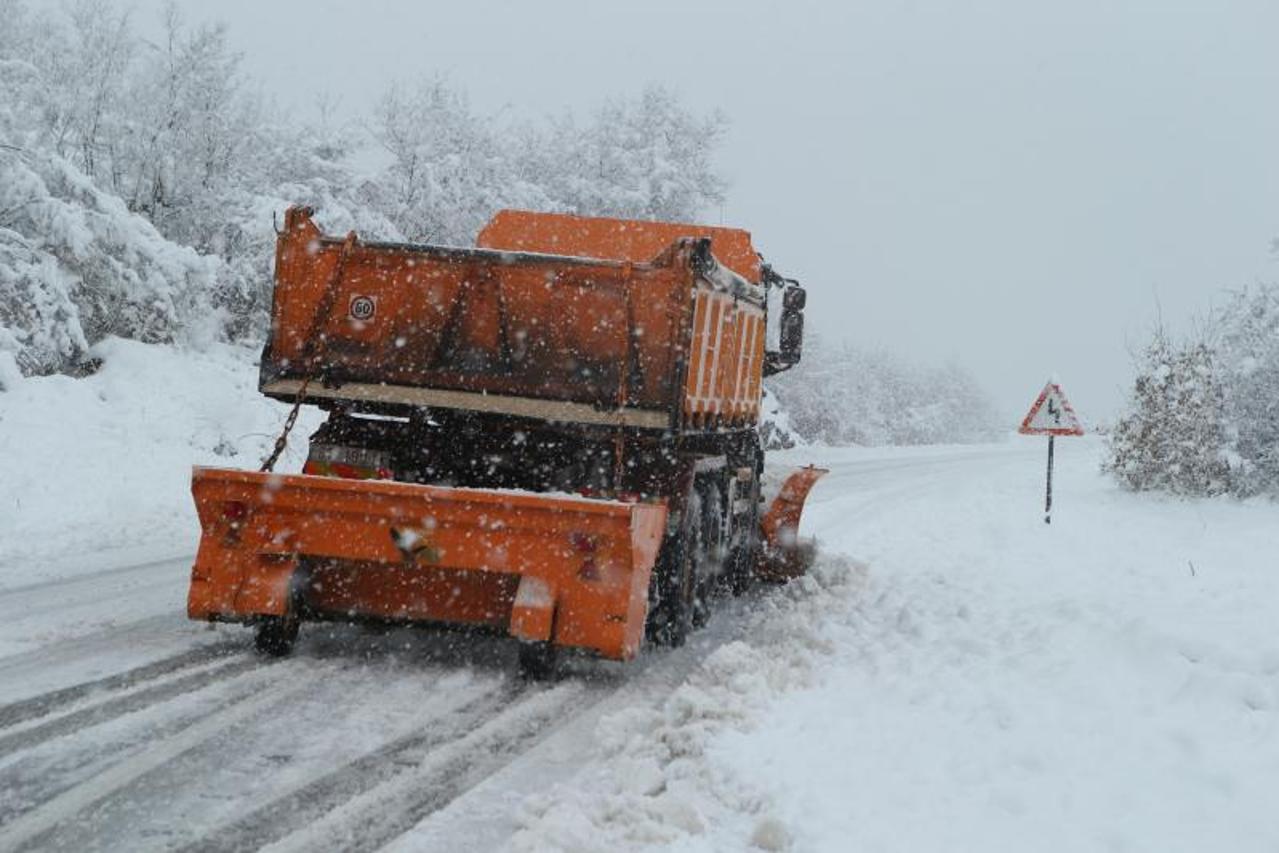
[0,440,1279,850]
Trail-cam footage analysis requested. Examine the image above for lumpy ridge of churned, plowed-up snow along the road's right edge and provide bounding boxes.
[512,558,863,852]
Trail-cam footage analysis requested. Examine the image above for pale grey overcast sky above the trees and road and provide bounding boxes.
[122,0,1279,417]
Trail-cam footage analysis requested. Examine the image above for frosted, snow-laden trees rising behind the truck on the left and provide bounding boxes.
[0,0,724,375]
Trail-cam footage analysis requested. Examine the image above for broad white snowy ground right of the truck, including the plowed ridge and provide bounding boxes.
[503,439,1279,850]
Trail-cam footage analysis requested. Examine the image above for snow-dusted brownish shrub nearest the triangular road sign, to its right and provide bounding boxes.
[1105,327,1230,495]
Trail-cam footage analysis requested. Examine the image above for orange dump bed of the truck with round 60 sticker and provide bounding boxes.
[262,208,765,430]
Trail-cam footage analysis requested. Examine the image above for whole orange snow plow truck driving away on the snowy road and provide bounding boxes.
[188,207,824,675]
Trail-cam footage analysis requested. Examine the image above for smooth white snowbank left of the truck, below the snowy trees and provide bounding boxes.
[0,339,315,590]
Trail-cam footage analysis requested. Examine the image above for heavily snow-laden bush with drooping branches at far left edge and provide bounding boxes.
[0,53,219,375]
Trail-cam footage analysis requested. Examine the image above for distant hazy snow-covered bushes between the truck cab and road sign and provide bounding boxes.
[769,334,1000,445]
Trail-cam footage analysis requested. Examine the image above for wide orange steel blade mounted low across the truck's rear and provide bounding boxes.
[187,468,666,660]
